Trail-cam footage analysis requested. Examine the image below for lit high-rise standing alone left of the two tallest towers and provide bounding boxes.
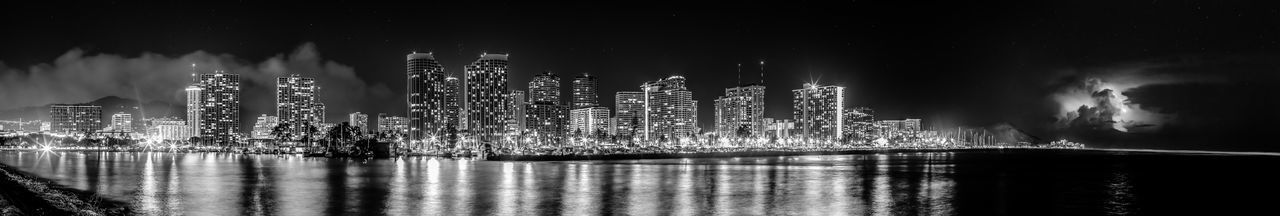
[276,74,324,135]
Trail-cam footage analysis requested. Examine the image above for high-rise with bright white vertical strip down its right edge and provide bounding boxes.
[791,83,845,141]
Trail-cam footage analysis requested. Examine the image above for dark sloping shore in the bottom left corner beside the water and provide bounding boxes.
[0,164,133,215]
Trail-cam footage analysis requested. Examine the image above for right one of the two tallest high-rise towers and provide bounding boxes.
[465,54,509,142]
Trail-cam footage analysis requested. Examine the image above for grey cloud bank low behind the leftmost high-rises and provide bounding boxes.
[0,43,396,124]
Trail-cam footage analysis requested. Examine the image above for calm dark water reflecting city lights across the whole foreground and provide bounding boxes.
[0,151,1280,215]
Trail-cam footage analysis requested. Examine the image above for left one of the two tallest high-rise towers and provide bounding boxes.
[407,52,453,147]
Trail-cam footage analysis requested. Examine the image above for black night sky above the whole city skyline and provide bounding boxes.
[0,0,1280,151]
